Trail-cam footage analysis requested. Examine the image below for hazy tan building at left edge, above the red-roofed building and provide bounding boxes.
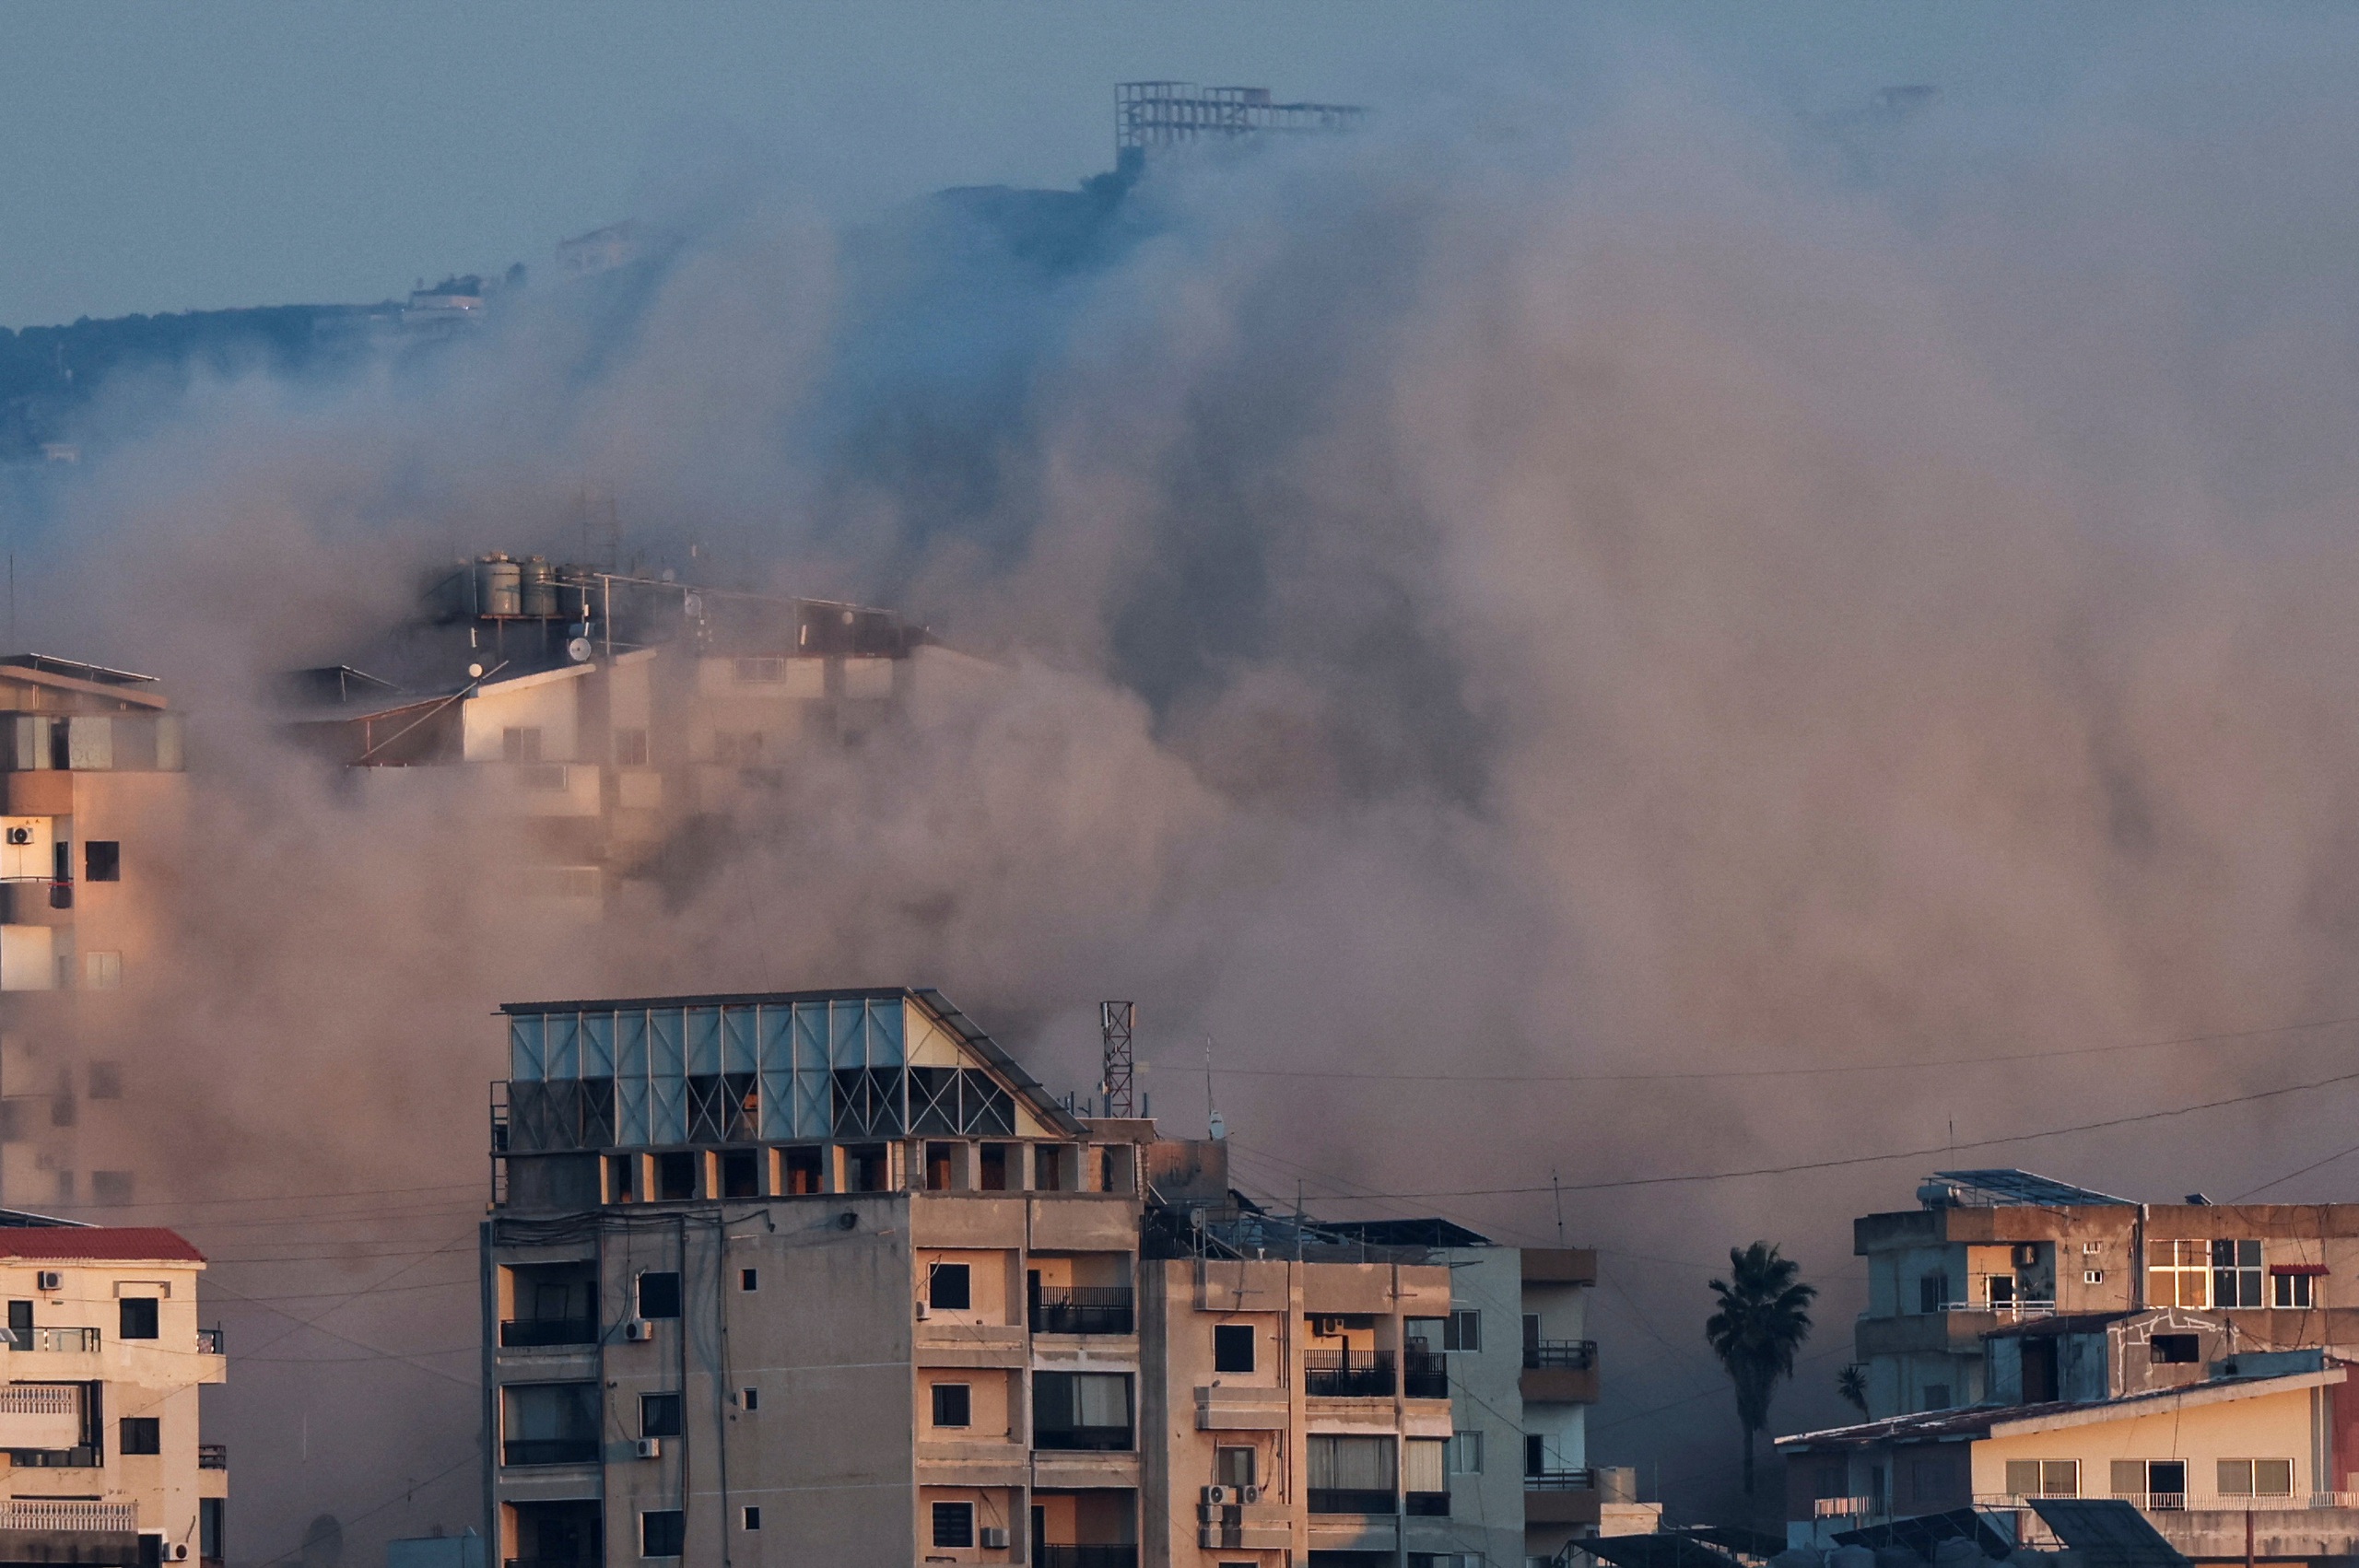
[0,653,186,1205]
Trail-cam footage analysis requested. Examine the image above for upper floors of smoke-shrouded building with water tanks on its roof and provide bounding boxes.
[288,554,967,915]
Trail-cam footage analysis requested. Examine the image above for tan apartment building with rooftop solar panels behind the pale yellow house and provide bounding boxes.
[1852,1169,2359,1420]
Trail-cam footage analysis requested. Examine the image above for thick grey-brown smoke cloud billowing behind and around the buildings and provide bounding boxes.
[26,29,2359,1556]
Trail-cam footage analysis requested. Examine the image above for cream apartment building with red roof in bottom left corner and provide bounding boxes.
[0,1210,229,1568]
